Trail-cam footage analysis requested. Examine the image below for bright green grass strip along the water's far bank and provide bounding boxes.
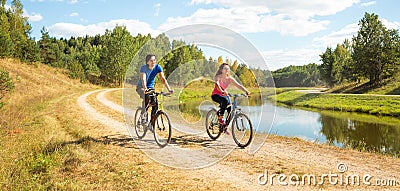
[271,91,400,117]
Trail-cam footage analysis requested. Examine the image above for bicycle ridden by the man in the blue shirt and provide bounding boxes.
[134,89,171,147]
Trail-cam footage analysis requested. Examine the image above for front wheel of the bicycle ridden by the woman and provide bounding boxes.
[232,113,253,148]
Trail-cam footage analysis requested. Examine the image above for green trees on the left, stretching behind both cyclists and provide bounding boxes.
[0,0,266,86]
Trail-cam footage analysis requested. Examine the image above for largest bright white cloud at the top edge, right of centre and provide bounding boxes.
[181,0,359,36]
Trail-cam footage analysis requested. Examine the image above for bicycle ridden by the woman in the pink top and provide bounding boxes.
[206,94,254,148]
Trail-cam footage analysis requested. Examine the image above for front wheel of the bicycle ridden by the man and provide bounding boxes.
[153,111,171,147]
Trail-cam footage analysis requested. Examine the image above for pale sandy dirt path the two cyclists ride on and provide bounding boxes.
[78,89,400,190]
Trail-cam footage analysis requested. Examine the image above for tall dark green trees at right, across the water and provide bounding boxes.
[319,13,400,87]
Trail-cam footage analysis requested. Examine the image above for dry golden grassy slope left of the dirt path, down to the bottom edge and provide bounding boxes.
[0,59,233,190]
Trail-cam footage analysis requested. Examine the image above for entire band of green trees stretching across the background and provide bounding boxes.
[0,0,400,95]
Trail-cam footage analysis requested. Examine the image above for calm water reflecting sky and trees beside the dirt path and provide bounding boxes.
[179,98,400,157]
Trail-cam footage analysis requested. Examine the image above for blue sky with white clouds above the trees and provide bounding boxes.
[14,0,400,70]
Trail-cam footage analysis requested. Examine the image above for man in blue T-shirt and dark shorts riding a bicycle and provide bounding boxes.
[136,54,174,121]
